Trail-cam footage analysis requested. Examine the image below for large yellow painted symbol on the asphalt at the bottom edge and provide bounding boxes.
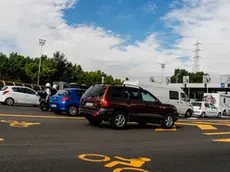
[78,154,151,172]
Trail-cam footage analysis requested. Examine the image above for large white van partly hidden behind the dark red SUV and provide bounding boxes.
[124,81,193,117]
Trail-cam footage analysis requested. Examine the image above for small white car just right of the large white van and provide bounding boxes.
[192,102,222,118]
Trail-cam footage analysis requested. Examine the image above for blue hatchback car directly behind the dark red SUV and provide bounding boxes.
[50,88,86,116]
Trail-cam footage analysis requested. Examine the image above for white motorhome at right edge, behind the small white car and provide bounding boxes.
[203,93,230,115]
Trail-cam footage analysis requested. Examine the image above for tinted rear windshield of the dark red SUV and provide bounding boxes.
[82,85,107,98]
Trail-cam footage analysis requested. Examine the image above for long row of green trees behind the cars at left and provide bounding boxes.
[0,51,122,85]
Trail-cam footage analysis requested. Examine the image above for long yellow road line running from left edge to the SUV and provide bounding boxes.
[0,114,85,120]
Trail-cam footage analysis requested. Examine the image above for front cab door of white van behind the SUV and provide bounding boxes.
[169,90,183,114]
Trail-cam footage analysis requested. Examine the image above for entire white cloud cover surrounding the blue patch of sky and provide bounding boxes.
[0,0,230,84]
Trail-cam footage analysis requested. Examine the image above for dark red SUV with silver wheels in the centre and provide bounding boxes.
[79,84,178,128]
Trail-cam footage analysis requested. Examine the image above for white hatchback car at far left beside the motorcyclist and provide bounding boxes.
[0,86,39,106]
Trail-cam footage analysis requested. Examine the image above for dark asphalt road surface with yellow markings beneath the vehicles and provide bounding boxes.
[0,106,230,172]
